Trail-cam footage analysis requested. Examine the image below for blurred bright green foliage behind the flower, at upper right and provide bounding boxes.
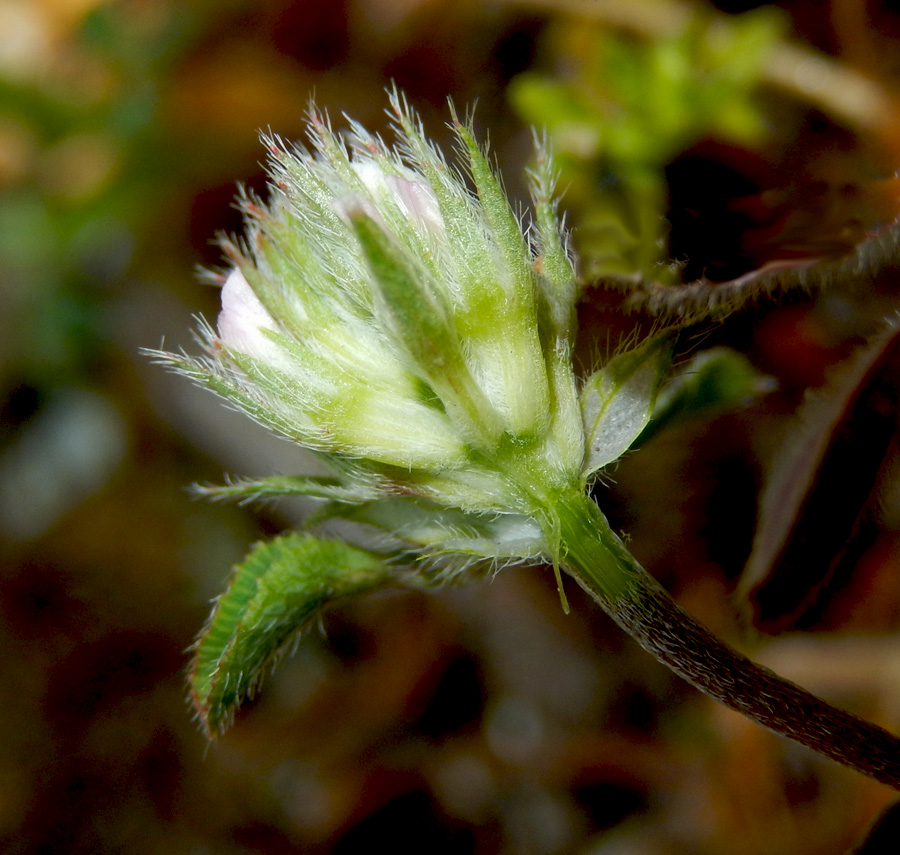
[510,9,786,282]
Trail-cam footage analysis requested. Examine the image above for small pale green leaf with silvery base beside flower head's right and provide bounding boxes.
[581,335,672,477]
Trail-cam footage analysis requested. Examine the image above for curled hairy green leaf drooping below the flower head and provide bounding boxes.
[190,534,391,737]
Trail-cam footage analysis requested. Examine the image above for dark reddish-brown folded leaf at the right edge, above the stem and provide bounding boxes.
[741,327,900,632]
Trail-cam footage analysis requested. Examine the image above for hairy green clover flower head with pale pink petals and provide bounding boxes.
[159,94,585,536]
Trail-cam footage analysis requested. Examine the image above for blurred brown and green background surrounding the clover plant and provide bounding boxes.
[0,0,900,855]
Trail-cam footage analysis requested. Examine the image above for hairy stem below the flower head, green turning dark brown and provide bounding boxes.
[557,493,900,789]
